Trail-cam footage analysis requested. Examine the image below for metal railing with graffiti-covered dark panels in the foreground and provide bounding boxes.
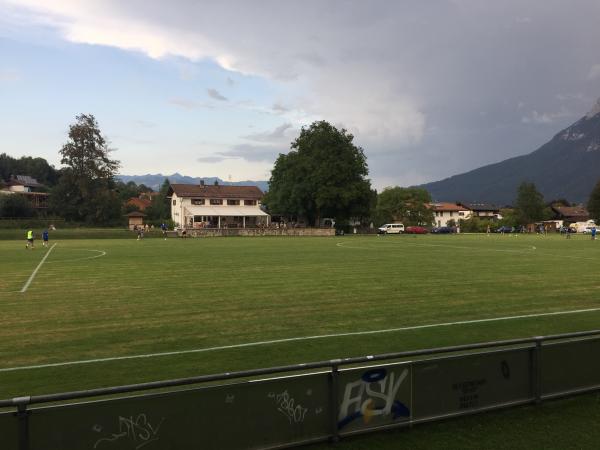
[0,330,600,450]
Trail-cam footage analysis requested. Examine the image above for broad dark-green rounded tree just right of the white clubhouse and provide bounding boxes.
[263,121,373,225]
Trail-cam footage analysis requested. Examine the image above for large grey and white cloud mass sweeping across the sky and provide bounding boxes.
[0,0,600,185]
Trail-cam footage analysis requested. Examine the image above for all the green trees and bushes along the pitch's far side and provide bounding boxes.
[0,114,600,231]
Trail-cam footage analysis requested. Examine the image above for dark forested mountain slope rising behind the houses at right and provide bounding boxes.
[419,99,600,205]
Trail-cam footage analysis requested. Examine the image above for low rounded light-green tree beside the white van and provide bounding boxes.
[376,186,433,226]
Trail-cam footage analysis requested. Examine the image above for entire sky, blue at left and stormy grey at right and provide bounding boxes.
[0,0,600,189]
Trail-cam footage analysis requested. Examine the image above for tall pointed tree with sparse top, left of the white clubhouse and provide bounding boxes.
[51,114,121,224]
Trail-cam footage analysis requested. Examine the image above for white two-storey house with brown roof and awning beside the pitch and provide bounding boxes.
[167,181,270,228]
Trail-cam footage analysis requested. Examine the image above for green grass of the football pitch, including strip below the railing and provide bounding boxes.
[0,234,600,448]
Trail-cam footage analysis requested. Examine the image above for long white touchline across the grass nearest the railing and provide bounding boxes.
[0,307,600,373]
